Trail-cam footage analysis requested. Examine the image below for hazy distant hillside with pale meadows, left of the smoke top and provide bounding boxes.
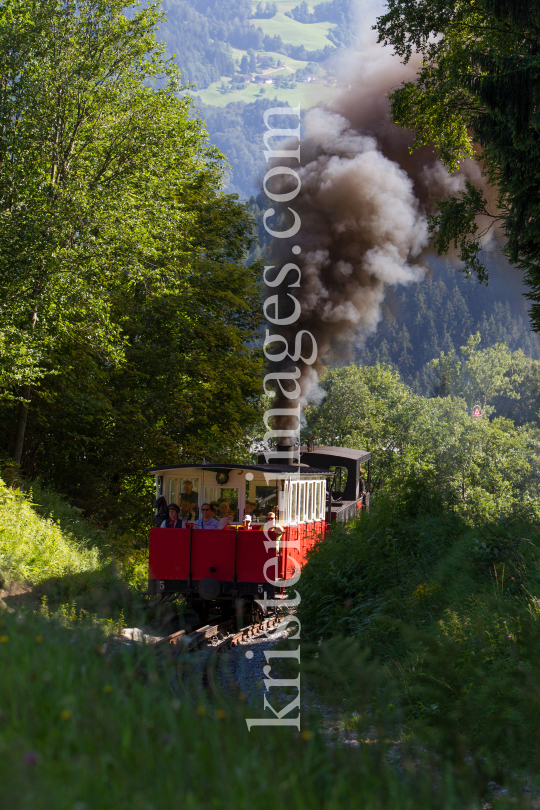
[150,0,355,198]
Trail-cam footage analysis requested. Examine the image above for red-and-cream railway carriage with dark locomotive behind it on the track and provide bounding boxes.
[148,447,370,613]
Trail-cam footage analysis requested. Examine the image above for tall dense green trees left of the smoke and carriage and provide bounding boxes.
[0,0,260,528]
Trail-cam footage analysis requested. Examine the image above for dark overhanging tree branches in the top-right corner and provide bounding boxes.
[377,0,540,330]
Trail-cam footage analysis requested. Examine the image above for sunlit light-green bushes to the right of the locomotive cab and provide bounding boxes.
[306,356,540,508]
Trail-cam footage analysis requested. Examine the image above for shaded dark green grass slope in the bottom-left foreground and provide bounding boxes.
[0,614,520,810]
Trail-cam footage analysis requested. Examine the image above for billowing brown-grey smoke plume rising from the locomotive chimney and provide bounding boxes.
[267,48,496,436]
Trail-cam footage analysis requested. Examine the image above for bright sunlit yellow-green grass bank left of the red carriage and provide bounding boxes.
[0,480,146,618]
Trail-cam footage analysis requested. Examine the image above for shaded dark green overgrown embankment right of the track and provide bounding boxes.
[300,499,540,781]
